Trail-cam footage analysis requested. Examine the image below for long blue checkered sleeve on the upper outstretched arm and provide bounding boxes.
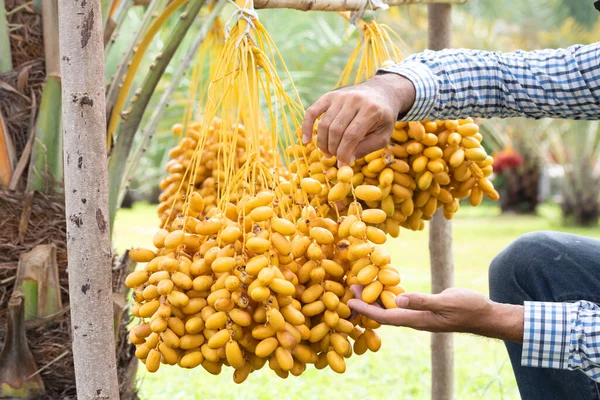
[379,43,600,121]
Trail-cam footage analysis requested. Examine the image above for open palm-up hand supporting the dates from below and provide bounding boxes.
[348,285,524,343]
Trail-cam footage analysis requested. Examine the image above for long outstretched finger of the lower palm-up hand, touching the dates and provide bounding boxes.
[347,299,426,329]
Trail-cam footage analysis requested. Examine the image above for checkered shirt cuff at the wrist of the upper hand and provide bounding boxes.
[377,61,439,121]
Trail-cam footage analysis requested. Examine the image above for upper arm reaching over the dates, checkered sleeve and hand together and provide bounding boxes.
[303,43,600,164]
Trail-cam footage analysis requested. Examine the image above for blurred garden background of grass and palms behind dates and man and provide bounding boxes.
[107,0,600,399]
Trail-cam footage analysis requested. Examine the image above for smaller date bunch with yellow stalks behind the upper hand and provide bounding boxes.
[292,15,499,237]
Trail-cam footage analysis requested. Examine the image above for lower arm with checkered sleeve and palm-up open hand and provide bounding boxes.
[348,285,600,382]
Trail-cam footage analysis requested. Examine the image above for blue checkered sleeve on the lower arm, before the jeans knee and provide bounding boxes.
[521,301,600,382]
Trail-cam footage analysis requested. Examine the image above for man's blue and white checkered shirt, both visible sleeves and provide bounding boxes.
[382,43,600,381]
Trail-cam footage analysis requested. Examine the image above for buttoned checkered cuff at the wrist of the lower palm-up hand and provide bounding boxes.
[521,301,577,369]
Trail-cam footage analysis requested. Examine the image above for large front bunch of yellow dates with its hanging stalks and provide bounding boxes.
[126,4,403,383]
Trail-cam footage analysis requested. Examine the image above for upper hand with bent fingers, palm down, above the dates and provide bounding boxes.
[302,73,415,165]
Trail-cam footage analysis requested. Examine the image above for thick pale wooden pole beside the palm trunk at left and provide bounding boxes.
[59,0,119,400]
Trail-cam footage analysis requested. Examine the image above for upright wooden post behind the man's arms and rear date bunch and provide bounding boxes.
[428,4,454,400]
